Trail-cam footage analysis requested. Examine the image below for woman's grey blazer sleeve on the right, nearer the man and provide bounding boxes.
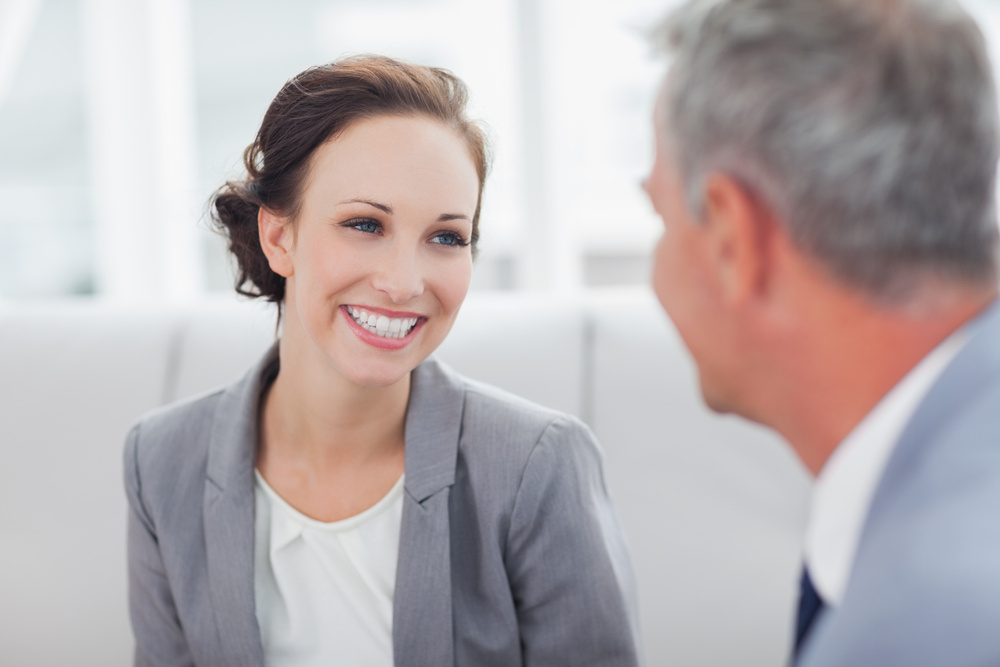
[506,417,640,667]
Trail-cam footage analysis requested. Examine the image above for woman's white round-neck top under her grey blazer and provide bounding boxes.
[254,471,403,667]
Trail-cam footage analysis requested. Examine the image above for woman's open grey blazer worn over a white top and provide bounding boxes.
[125,349,638,667]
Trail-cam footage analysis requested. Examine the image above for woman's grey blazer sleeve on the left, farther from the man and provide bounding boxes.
[125,424,194,667]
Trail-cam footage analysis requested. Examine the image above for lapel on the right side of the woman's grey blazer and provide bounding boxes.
[392,359,465,667]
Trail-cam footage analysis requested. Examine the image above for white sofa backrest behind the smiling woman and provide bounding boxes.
[0,289,809,667]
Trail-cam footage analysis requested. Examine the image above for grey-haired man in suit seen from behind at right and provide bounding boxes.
[645,0,1000,667]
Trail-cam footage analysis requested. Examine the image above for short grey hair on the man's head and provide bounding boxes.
[653,0,998,301]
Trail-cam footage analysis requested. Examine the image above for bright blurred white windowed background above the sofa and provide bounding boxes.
[0,0,674,301]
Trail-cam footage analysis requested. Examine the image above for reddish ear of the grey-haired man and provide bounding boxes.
[703,173,776,304]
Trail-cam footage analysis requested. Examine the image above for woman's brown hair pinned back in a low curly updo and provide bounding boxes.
[211,56,489,303]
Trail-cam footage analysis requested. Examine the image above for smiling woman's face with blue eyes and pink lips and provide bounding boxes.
[261,116,479,386]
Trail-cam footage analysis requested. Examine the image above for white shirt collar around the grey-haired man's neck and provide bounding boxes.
[804,328,968,607]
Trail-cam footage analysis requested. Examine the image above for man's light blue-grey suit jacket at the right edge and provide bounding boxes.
[799,303,1000,667]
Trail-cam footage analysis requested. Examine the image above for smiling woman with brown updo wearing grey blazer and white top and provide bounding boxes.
[125,57,638,667]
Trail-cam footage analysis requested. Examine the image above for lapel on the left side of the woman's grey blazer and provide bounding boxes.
[204,346,277,667]
